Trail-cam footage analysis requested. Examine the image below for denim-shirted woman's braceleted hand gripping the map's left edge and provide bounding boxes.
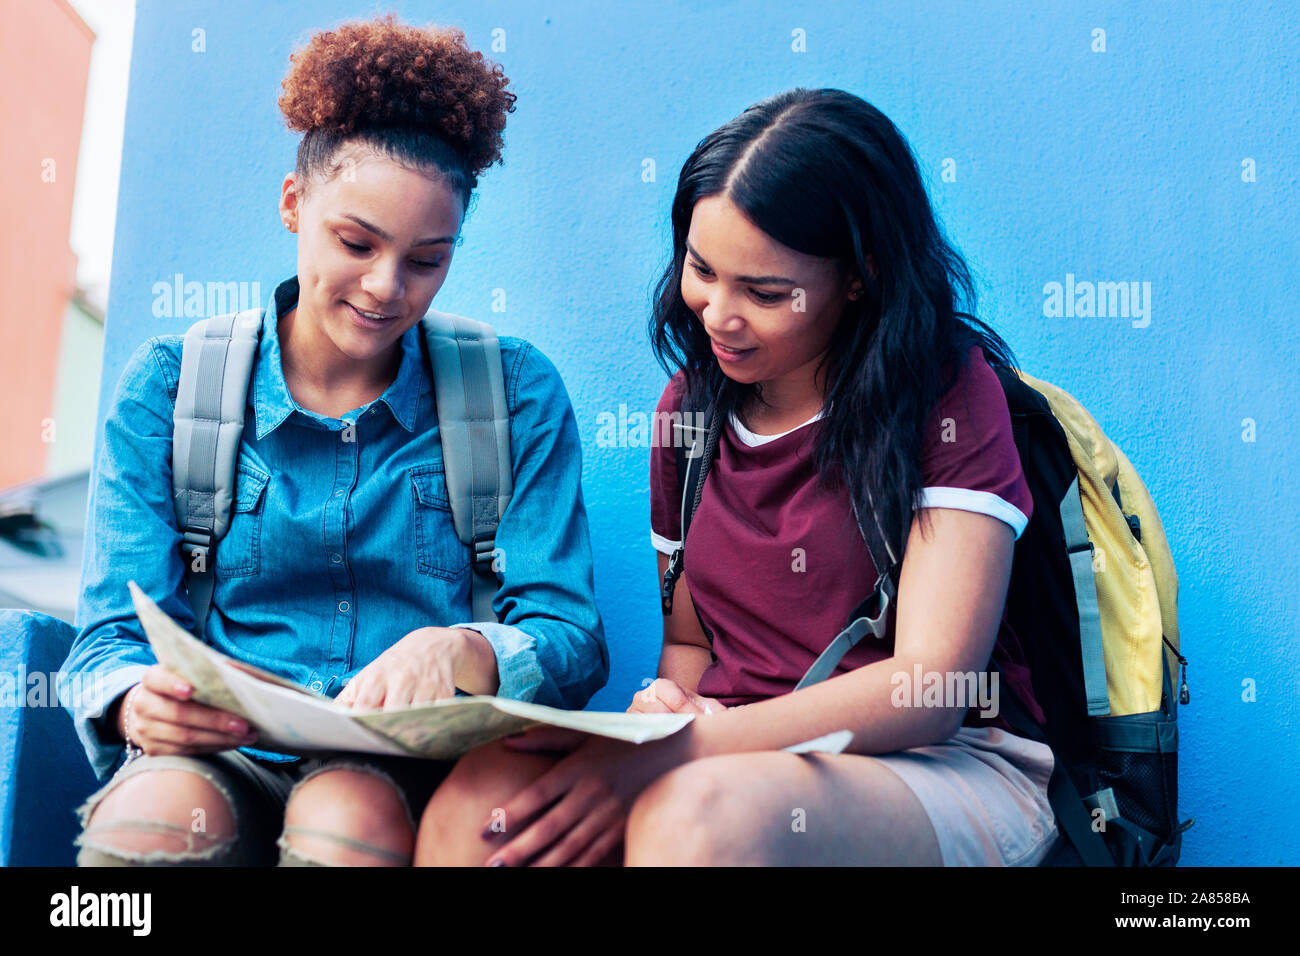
[117,663,257,757]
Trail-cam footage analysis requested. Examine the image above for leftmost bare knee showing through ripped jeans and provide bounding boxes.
[78,770,235,862]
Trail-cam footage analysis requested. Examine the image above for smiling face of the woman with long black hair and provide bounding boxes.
[681,195,861,403]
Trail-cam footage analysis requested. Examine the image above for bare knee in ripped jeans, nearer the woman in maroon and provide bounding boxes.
[280,767,415,866]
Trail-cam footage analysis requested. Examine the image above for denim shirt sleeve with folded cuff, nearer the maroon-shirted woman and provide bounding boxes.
[454,339,610,709]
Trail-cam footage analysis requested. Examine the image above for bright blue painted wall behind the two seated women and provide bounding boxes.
[100,0,1300,864]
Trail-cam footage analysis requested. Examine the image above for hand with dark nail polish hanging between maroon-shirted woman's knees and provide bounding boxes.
[482,727,690,866]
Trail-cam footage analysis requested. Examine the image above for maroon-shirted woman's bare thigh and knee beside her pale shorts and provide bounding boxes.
[625,750,943,866]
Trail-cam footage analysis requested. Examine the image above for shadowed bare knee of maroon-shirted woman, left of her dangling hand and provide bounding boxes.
[415,740,558,866]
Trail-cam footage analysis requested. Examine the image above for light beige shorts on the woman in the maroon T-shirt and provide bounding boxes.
[875,727,1060,866]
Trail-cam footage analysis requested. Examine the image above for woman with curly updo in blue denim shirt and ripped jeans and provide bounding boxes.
[64,16,608,866]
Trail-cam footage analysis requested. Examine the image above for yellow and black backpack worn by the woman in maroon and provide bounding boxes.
[995,367,1192,866]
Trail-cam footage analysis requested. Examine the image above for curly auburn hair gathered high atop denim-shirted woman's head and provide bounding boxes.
[280,13,516,202]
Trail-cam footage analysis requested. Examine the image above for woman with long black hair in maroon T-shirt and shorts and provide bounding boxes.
[416,88,1057,866]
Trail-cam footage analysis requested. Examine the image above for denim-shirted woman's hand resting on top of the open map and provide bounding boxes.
[334,627,469,710]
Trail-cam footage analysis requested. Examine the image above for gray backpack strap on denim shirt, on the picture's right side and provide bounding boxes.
[420,311,514,622]
